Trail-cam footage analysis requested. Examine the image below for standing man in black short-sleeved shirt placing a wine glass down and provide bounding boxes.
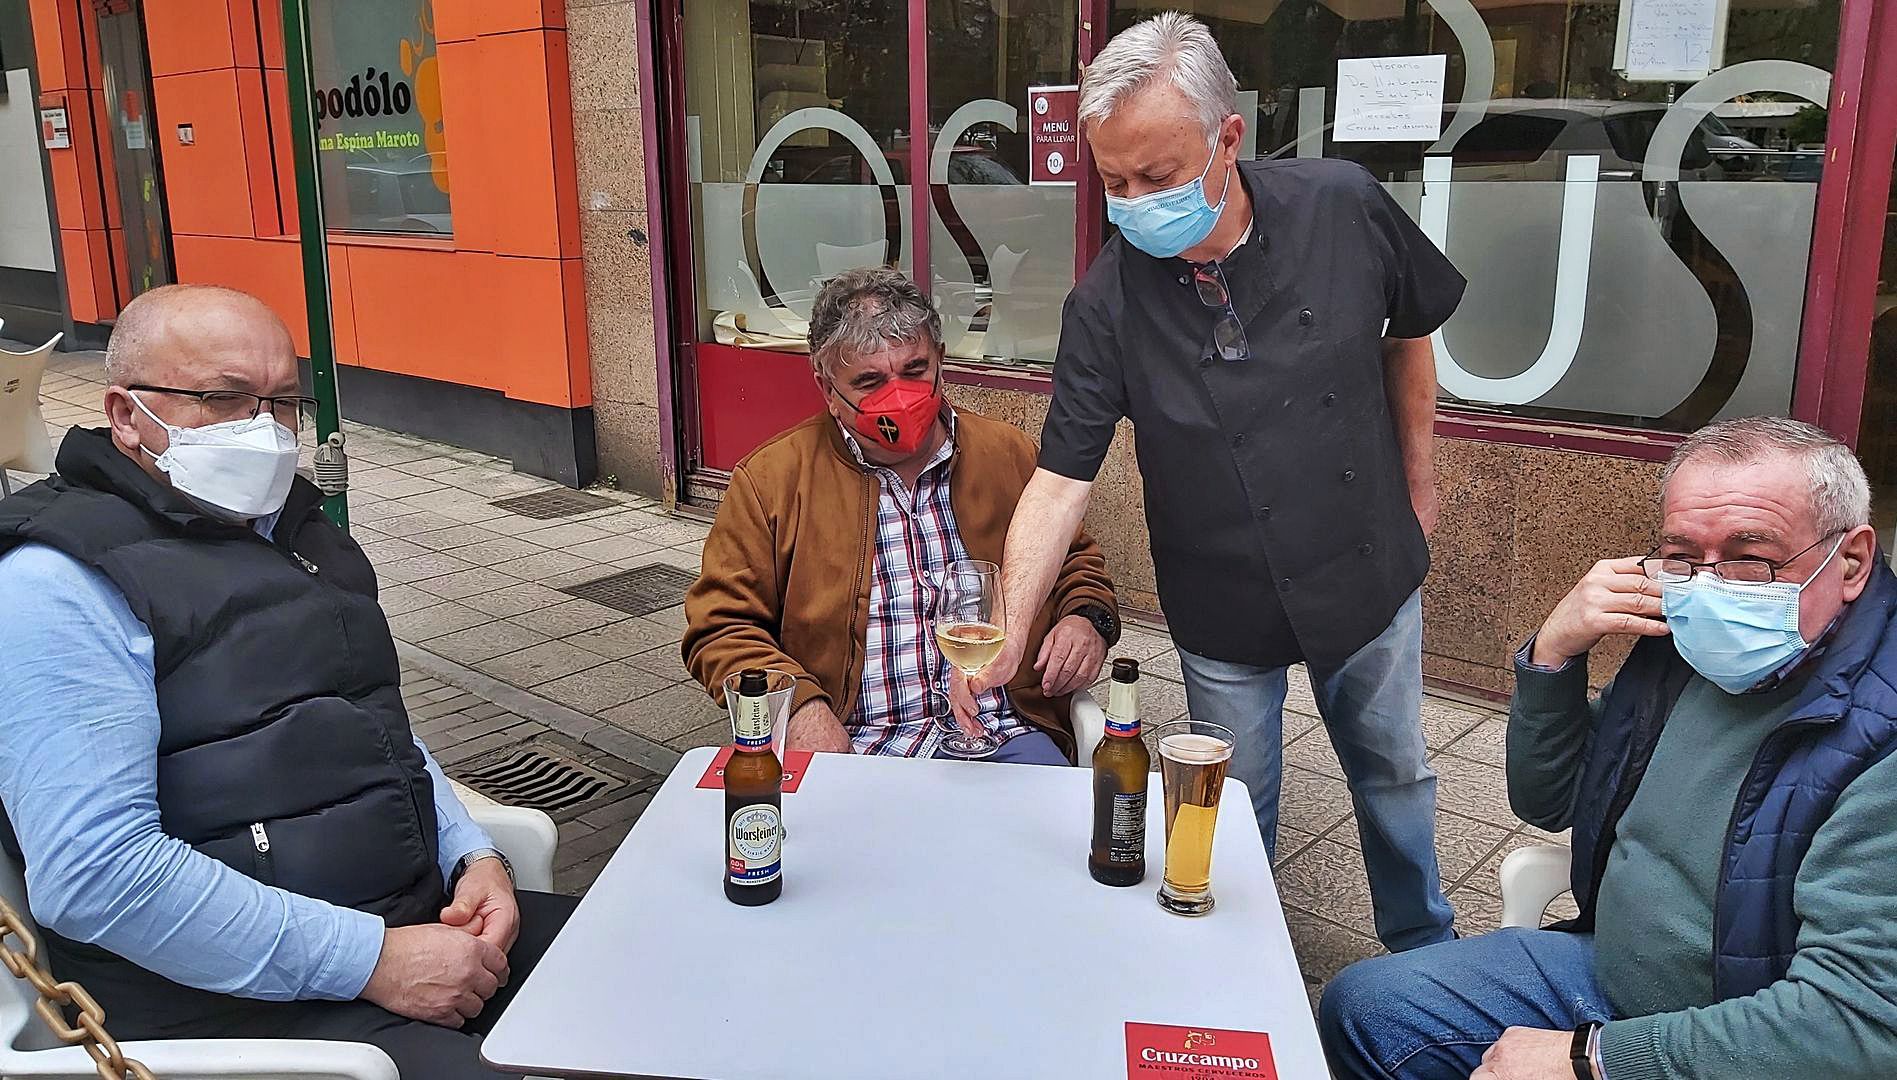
[977,13,1463,951]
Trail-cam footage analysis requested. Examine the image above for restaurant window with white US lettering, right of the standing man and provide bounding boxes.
[1110,0,1840,433]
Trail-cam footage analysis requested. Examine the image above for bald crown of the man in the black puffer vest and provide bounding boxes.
[106,285,296,393]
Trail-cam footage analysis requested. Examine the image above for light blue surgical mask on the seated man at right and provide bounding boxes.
[1660,535,1844,695]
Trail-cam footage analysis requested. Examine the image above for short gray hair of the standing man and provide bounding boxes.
[1079,11,1239,140]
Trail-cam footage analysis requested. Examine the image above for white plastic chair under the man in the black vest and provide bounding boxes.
[0,784,558,1080]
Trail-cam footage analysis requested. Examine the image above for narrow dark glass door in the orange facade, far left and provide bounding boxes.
[99,2,173,304]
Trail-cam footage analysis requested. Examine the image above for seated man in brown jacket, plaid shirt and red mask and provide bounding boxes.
[683,268,1119,765]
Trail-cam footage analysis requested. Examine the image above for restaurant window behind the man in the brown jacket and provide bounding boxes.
[681,0,1077,364]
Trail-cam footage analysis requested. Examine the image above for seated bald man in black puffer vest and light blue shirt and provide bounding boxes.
[0,287,573,1080]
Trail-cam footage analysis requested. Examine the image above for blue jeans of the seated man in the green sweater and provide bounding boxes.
[1317,928,1614,1080]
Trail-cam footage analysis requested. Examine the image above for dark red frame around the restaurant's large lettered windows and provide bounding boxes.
[637,0,1897,492]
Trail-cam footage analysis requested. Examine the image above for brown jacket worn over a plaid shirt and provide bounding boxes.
[683,410,1117,757]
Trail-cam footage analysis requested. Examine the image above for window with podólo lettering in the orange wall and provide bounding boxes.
[309,0,453,235]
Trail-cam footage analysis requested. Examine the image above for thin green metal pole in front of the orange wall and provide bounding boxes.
[283,0,349,530]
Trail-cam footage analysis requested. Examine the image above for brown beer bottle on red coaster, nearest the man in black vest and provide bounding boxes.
[725,668,783,907]
